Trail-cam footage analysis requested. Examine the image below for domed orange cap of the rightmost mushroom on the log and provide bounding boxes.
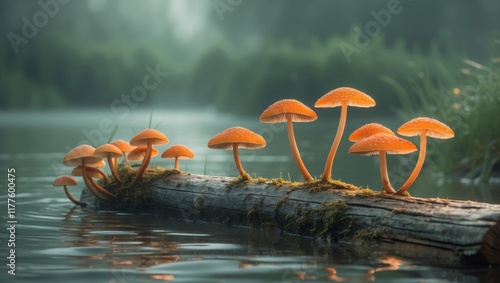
[398,117,455,139]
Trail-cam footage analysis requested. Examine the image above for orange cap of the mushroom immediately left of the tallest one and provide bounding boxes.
[259,99,318,123]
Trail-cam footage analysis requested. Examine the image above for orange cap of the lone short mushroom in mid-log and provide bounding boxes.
[208,127,266,149]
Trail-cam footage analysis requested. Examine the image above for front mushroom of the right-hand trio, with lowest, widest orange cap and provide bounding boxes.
[349,133,417,194]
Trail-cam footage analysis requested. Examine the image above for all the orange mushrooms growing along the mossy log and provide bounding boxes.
[54,87,454,205]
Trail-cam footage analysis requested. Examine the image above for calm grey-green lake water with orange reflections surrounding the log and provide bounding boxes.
[0,110,500,283]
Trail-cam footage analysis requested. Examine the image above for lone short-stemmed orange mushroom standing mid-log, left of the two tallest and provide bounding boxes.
[208,127,266,180]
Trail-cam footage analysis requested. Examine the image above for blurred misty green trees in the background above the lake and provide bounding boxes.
[0,0,500,115]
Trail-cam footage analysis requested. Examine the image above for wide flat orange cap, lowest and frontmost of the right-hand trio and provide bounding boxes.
[349,133,417,155]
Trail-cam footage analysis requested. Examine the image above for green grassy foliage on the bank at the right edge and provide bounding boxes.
[392,44,500,181]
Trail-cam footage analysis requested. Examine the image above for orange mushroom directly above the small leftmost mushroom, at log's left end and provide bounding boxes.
[63,144,114,200]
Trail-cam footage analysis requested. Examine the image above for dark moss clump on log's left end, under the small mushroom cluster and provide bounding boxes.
[96,166,181,212]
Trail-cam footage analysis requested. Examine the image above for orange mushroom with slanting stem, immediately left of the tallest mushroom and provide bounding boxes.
[259,99,318,181]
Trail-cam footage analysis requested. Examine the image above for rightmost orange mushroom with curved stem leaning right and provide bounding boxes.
[396,117,455,195]
